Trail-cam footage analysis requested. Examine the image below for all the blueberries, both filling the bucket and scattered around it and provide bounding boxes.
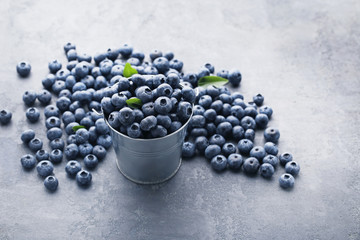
[11,43,299,191]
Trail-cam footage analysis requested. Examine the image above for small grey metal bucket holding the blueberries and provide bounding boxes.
[95,109,192,184]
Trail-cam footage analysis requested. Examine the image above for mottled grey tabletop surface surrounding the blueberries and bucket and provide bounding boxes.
[0,0,360,239]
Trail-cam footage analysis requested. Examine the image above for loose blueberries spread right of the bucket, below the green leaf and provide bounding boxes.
[182,85,300,188]
